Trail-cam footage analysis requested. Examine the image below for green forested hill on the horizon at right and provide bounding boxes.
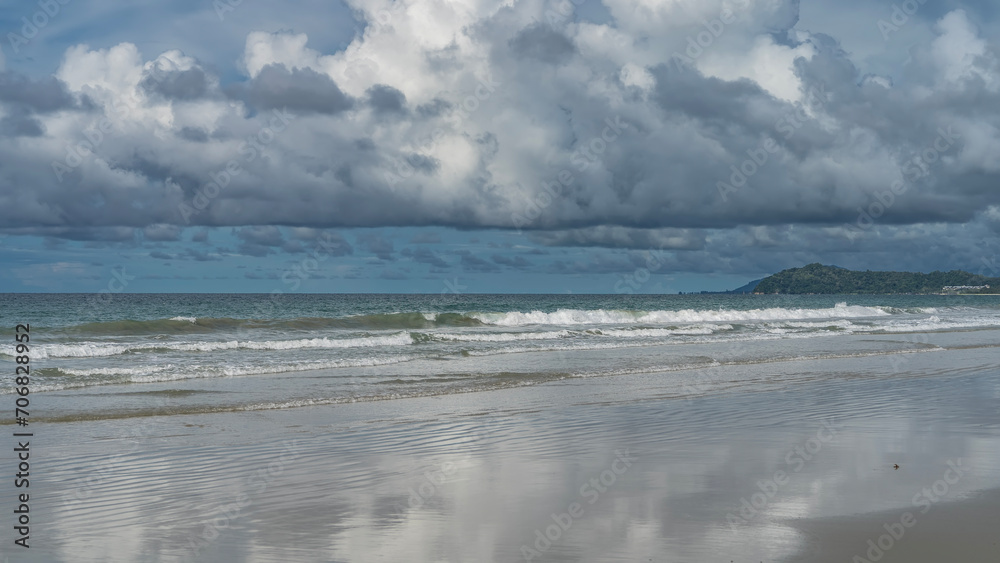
[753,264,1000,295]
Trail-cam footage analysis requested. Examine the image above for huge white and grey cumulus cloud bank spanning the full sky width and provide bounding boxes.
[0,0,1000,271]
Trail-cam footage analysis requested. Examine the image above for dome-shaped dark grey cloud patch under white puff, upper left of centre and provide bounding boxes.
[247,64,354,114]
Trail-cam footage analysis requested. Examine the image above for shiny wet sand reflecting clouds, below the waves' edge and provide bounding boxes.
[2,334,1000,563]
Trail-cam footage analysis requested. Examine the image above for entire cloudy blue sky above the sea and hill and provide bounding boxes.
[0,0,1000,293]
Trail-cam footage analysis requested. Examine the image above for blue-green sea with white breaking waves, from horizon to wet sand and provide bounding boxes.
[0,294,1000,424]
